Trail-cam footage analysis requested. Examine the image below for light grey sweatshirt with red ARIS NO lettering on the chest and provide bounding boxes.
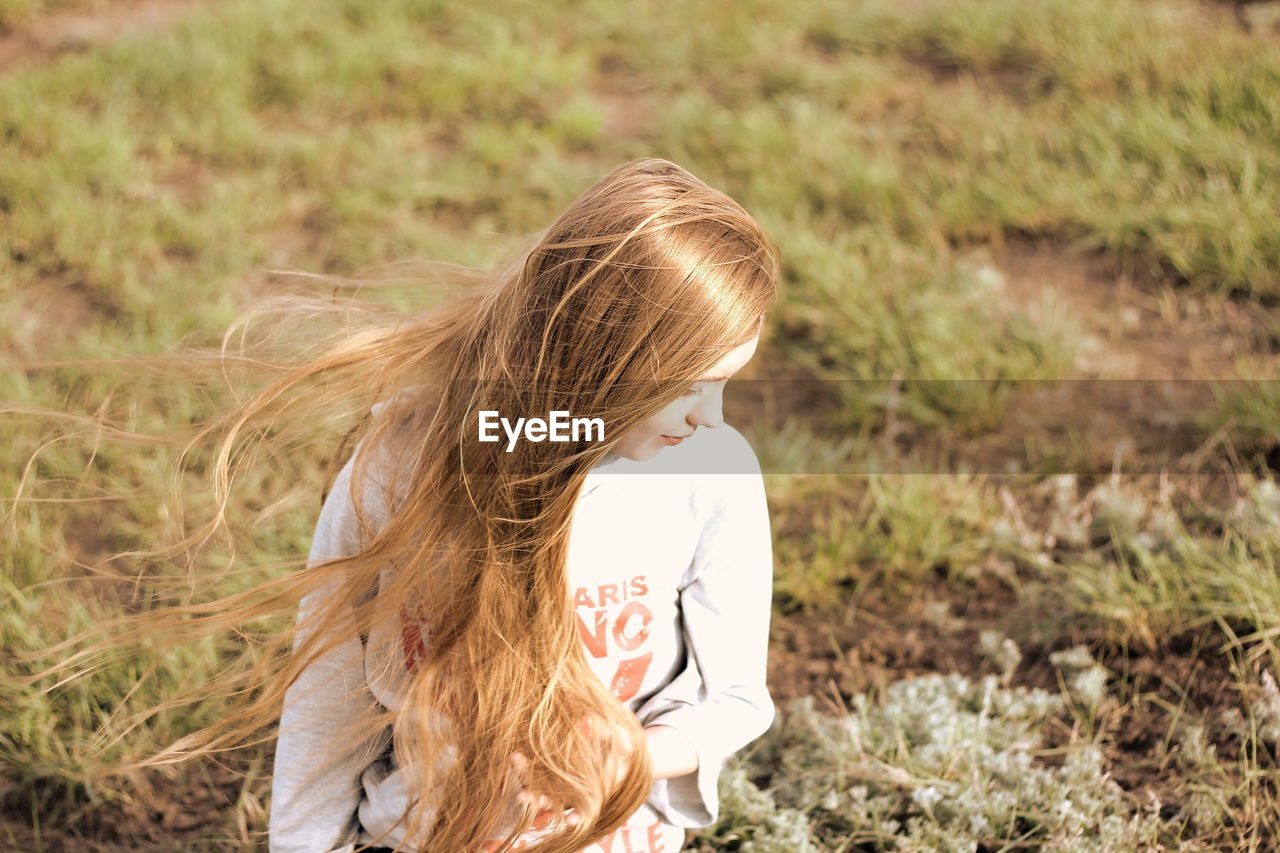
[270,424,773,853]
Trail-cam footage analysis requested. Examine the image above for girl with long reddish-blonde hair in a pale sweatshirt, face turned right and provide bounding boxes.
[270,159,778,853]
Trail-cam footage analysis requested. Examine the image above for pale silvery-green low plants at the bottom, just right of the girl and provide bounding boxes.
[701,676,1161,853]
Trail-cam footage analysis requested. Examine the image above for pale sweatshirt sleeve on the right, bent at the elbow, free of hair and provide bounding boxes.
[636,425,774,827]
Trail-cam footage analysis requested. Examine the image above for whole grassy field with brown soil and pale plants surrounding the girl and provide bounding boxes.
[0,0,1280,853]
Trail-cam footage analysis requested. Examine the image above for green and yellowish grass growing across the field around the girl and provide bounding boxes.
[0,0,1280,849]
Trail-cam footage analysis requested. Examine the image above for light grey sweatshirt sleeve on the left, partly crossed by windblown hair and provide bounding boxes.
[269,451,389,853]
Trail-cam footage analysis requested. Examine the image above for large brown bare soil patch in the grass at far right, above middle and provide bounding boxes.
[972,241,1280,474]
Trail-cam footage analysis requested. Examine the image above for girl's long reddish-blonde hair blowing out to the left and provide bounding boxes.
[30,159,778,853]
